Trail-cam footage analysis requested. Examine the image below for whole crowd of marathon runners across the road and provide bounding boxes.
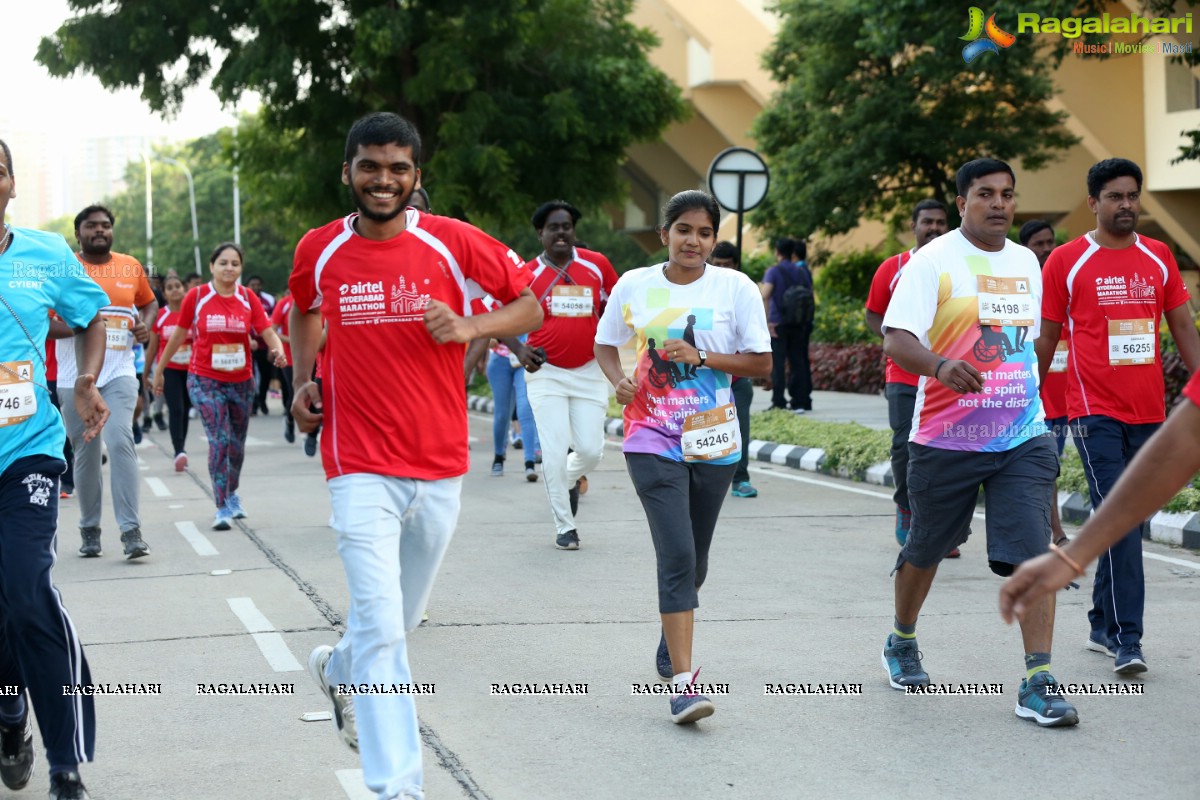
[0,113,1200,800]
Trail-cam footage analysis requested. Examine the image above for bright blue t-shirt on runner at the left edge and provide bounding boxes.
[0,228,108,472]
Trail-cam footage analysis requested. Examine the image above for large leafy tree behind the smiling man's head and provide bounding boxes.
[37,0,683,232]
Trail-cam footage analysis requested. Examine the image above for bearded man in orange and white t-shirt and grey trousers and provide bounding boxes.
[52,205,158,559]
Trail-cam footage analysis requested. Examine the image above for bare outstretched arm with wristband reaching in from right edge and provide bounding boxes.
[1000,374,1200,622]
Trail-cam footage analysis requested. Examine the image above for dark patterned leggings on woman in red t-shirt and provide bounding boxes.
[187,373,254,509]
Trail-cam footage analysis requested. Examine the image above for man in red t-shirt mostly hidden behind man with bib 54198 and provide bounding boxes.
[866,199,940,558]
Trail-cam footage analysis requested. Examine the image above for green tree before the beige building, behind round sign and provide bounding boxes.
[751,0,1076,234]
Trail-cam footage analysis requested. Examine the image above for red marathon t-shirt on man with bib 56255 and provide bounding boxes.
[1042,235,1188,425]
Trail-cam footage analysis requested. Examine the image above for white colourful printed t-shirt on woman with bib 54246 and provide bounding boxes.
[595,264,770,464]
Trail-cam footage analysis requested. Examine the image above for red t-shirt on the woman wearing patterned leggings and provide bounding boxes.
[176,283,271,384]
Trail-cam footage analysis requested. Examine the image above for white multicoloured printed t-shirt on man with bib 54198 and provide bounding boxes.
[883,229,1046,452]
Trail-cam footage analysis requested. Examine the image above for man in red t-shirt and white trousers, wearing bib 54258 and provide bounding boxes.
[504,200,617,551]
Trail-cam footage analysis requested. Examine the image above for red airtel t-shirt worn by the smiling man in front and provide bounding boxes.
[288,209,528,480]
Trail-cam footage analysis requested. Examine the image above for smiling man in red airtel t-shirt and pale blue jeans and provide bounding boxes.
[289,113,541,798]
